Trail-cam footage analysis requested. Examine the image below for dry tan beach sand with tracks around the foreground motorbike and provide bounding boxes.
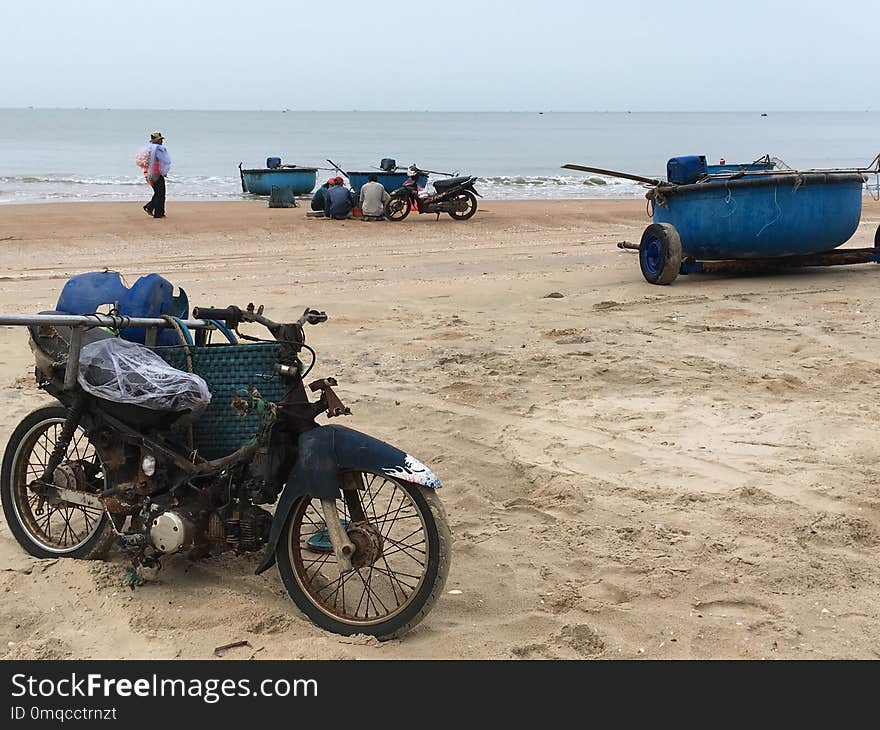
[0,199,880,658]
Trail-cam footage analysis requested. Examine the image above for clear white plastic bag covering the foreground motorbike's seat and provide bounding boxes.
[78,337,211,414]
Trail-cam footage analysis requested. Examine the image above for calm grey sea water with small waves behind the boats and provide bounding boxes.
[0,109,880,203]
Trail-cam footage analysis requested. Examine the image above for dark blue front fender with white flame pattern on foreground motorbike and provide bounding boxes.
[256,426,441,575]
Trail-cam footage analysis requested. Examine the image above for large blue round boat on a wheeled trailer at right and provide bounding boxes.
[639,156,865,284]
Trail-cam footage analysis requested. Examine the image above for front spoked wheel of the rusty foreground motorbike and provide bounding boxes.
[276,472,452,639]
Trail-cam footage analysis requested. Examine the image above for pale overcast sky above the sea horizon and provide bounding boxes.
[6,0,880,111]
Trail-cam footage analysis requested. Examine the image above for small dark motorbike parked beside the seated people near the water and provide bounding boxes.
[385,166,482,221]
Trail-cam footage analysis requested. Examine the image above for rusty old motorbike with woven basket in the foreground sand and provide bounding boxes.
[0,304,451,639]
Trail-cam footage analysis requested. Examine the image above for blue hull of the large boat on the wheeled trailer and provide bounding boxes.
[650,172,864,261]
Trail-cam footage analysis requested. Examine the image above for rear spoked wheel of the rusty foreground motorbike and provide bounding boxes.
[0,406,114,559]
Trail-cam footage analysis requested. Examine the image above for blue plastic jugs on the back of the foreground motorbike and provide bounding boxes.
[55,271,189,345]
